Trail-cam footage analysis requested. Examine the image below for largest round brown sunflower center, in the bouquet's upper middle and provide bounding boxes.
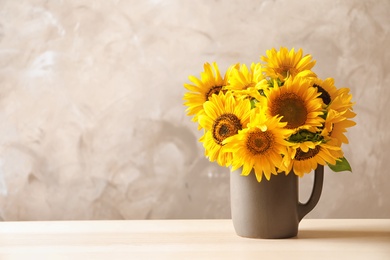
[271,92,307,129]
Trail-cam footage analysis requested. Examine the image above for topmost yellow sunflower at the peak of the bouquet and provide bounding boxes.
[261,47,316,81]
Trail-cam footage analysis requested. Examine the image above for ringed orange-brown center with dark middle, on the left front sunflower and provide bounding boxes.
[212,114,242,145]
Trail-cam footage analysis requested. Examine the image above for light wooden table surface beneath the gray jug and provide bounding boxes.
[0,219,390,260]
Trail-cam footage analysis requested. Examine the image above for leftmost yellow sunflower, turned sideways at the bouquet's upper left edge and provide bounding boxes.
[183,62,237,122]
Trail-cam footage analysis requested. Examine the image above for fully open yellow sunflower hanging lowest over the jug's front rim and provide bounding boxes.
[223,108,288,182]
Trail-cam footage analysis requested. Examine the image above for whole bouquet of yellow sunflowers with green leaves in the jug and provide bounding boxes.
[184,47,356,182]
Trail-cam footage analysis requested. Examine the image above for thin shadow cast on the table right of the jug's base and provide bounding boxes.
[297,230,390,240]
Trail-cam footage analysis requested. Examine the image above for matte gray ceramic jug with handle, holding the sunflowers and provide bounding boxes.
[230,165,324,238]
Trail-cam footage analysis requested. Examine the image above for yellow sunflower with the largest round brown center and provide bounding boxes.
[259,74,324,132]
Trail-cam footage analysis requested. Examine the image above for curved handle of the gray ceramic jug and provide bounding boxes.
[298,165,324,221]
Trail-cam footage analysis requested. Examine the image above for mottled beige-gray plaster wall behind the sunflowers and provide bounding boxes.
[0,0,390,220]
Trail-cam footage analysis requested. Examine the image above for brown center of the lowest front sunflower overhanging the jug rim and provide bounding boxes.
[246,130,273,155]
